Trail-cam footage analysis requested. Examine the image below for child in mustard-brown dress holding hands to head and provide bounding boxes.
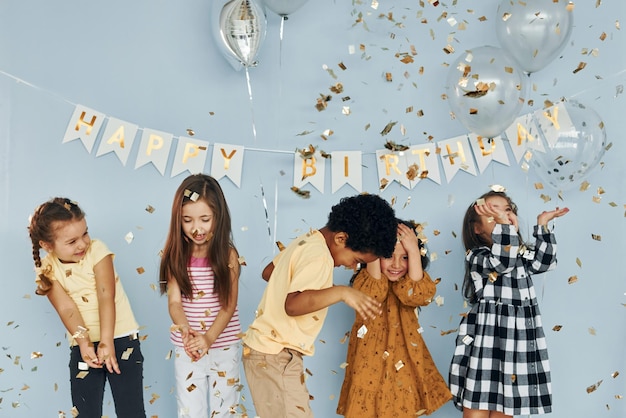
[337,221,452,418]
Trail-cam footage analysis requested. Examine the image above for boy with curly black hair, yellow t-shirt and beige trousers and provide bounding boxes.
[243,194,397,418]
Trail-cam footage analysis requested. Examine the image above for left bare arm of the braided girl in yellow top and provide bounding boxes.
[47,280,102,368]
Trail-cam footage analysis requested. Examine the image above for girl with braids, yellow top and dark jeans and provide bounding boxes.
[28,197,146,418]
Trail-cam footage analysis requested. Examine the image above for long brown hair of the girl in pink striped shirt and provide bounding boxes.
[159,174,236,306]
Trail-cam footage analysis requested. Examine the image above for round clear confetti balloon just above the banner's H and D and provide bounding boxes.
[446,46,527,138]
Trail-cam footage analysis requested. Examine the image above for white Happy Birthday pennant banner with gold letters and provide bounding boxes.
[63,102,573,193]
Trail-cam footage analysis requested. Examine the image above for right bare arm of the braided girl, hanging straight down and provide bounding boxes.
[93,255,120,374]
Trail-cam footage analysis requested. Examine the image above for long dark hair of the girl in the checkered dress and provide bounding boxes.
[462,190,522,304]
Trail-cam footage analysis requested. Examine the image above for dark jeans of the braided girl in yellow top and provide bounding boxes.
[69,335,146,418]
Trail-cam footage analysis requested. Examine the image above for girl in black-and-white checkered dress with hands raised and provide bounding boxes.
[449,191,569,418]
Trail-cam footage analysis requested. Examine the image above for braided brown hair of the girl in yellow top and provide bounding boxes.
[28,197,85,295]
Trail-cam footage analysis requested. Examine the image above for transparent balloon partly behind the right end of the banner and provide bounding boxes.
[530,100,606,190]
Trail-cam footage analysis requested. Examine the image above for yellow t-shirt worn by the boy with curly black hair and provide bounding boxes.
[243,230,334,356]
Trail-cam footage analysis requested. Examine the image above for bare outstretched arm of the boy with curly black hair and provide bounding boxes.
[285,286,382,319]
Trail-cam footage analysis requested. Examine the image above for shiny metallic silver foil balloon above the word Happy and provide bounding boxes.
[215,0,267,70]
